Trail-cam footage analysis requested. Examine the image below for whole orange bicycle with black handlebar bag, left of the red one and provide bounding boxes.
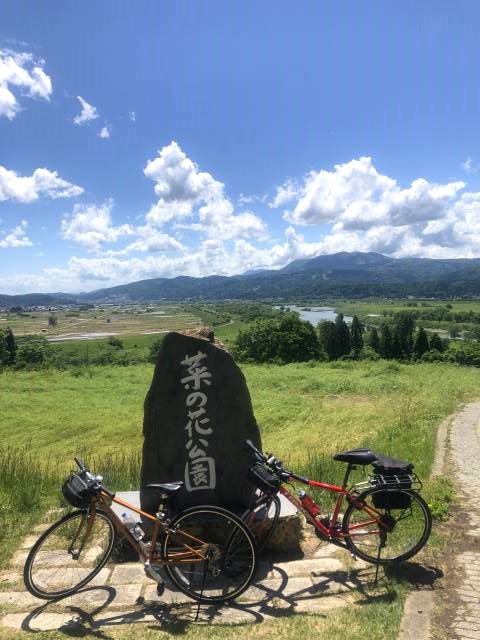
[24,458,257,603]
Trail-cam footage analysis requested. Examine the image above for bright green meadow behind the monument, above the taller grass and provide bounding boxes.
[0,361,480,464]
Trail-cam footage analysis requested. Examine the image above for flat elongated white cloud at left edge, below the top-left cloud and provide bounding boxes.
[0,166,83,202]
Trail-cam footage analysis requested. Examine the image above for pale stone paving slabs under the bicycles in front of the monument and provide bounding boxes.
[0,549,355,632]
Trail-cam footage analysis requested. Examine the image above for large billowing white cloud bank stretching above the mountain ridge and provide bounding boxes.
[6,154,480,291]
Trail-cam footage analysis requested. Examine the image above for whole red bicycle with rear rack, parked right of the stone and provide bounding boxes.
[242,440,432,565]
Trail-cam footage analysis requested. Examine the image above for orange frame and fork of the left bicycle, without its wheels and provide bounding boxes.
[75,490,208,565]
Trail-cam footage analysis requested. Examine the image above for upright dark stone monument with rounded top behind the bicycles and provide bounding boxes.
[140,332,261,512]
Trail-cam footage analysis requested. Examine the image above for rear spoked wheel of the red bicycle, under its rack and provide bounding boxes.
[342,488,432,564]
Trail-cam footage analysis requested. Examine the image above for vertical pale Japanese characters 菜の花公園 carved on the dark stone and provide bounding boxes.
[180,351,216,492]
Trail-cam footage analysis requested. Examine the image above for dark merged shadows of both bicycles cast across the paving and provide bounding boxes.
[16,565,397,640]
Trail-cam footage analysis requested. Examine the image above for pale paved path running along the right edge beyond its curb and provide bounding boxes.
[448,402,480,640]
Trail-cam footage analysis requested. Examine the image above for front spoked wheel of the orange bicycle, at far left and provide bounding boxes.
[23,511,115,600]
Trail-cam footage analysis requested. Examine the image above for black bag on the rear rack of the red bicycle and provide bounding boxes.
[372,454,414,510]
